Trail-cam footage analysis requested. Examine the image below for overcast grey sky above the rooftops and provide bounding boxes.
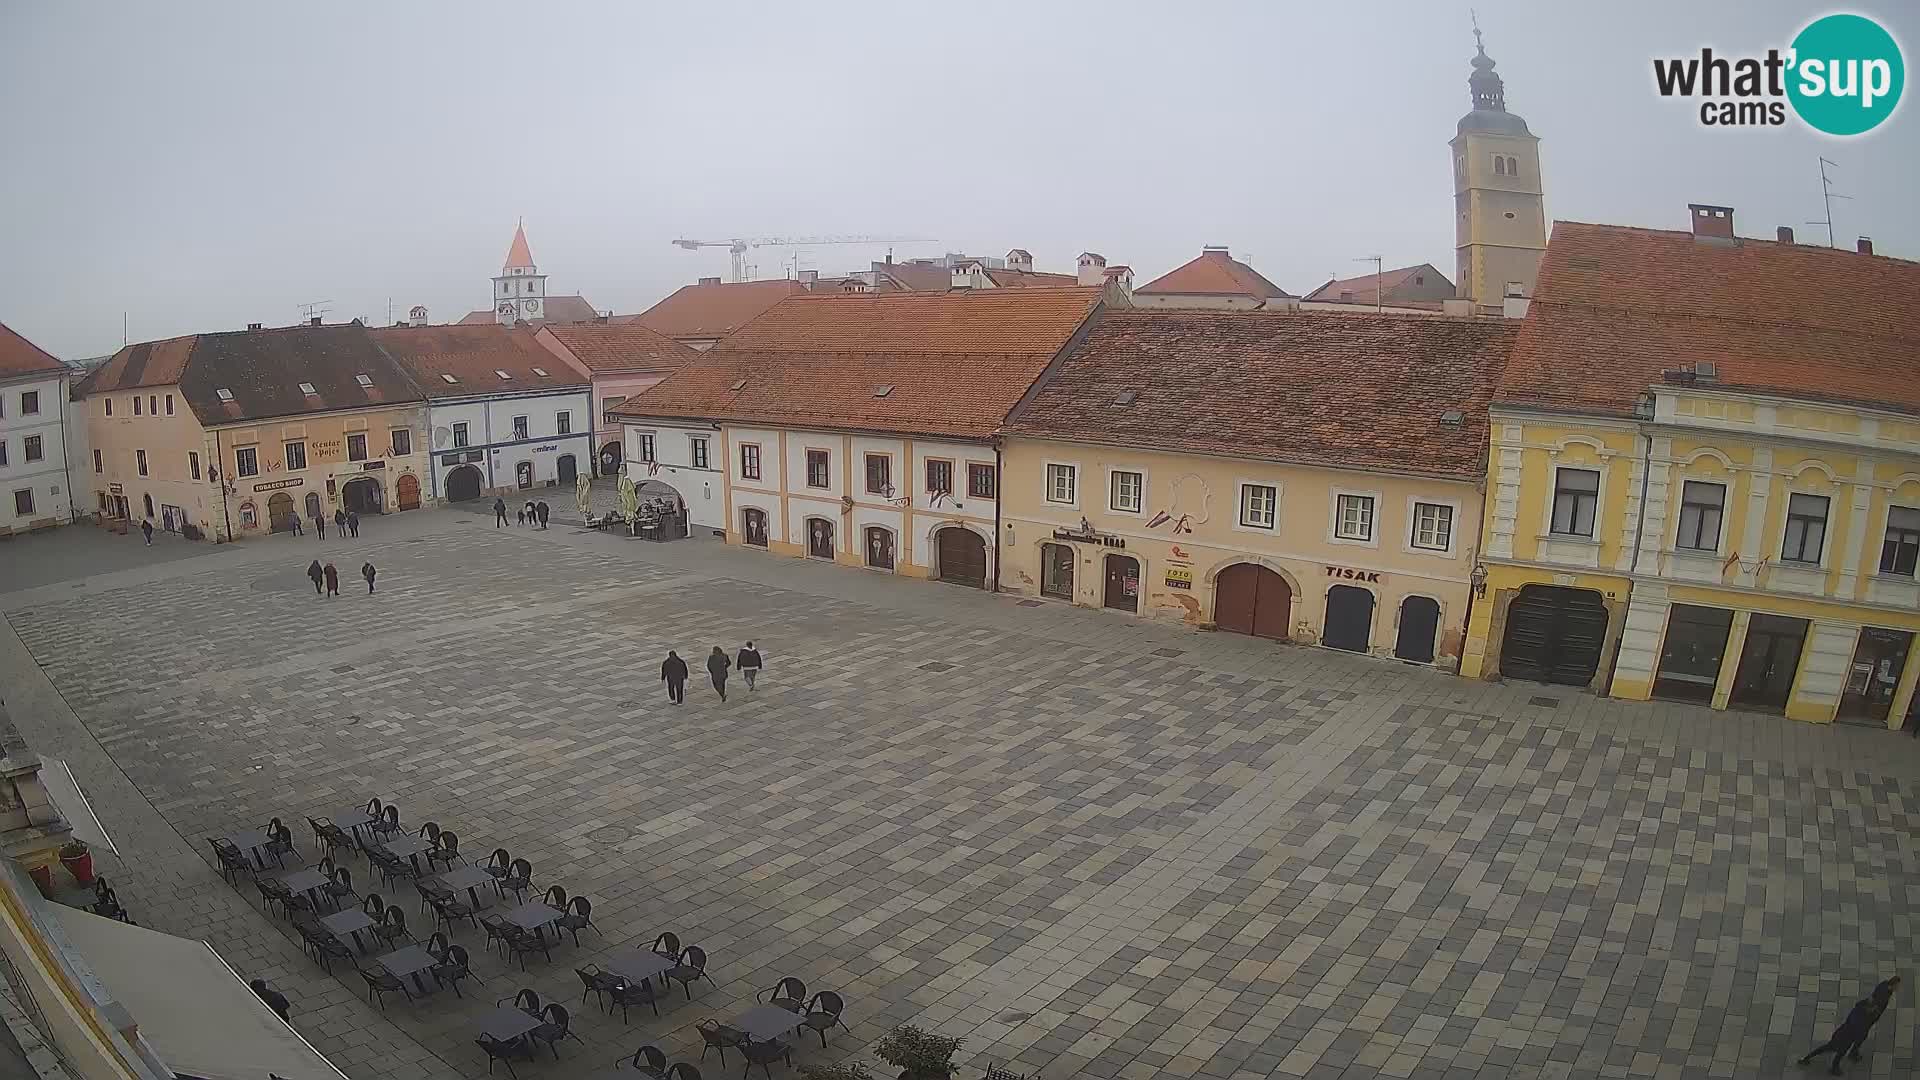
[0,0,1920,357]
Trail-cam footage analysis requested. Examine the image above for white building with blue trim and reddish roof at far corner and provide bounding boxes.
[372,325,593,503]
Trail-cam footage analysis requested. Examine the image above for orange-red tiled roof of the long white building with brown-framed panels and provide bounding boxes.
[614,288,1100,438]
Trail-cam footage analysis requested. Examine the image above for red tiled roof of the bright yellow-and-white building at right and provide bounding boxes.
[1496,221,1920,415]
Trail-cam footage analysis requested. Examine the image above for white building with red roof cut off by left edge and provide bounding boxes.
[0,325,73,536]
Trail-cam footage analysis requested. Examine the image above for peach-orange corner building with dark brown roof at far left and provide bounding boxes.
[75,323,428,540]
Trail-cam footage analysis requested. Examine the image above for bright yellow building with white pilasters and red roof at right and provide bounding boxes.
[1463,206,1920,726]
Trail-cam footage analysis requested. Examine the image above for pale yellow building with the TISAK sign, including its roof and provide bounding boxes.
[1000,311,1517,669]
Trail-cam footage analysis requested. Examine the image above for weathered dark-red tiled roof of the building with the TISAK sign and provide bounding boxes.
[1006,311,1517,480]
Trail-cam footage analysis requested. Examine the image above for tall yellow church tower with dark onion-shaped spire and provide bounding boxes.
[1450,19,1548,311]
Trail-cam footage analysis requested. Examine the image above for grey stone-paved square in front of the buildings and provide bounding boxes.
[0,500,1920,1080]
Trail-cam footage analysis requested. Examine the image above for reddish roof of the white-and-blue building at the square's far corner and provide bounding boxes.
[372,327,588,398]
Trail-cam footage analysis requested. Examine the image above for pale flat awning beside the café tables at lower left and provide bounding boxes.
[48,905,346,1080]
